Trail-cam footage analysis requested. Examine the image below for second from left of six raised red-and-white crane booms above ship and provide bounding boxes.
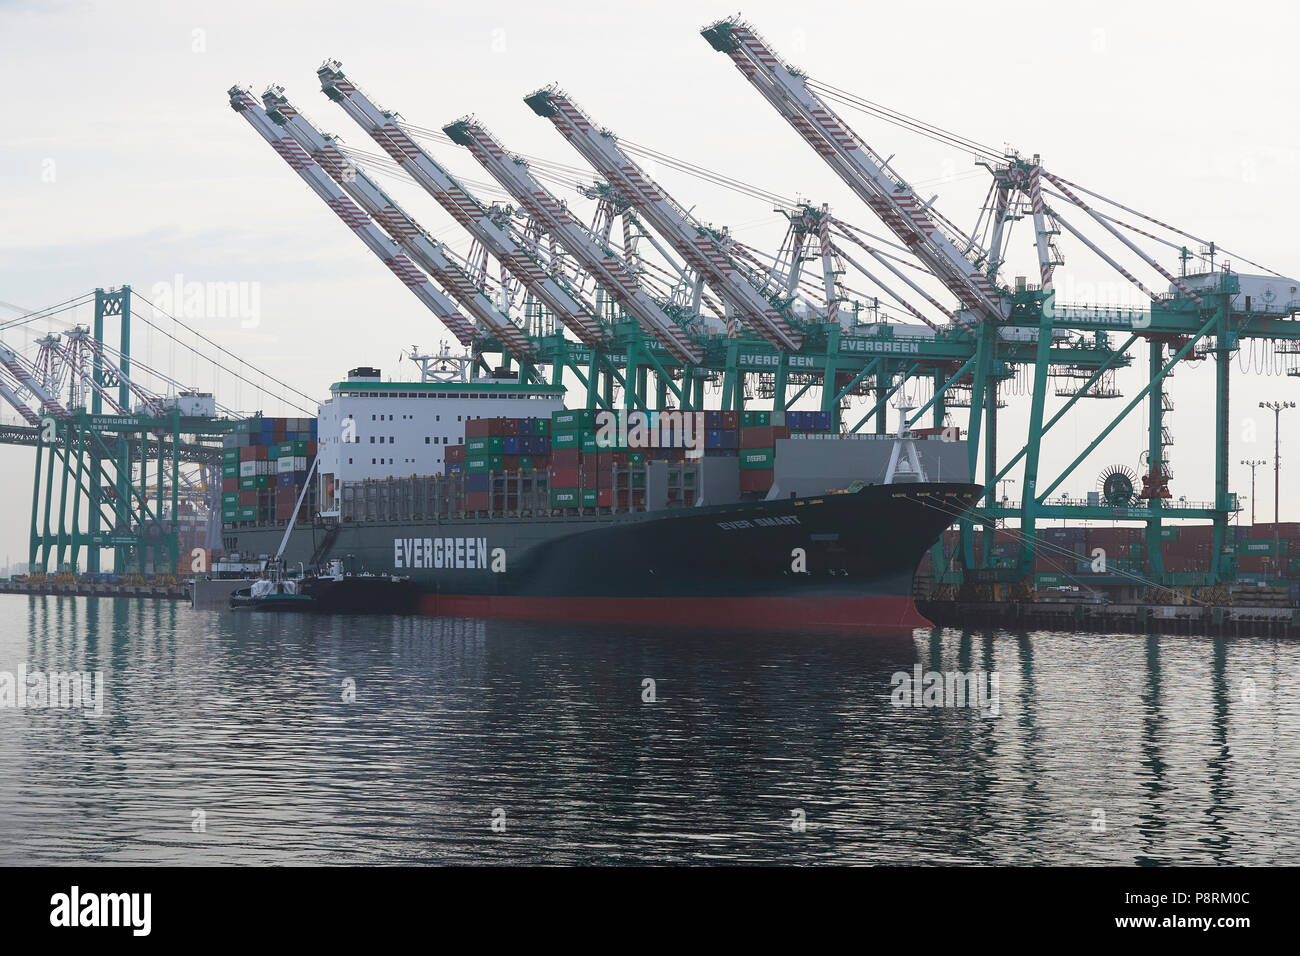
[263,87,534,360]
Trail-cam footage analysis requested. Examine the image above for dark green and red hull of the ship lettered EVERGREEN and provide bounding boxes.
[220,483,980,635]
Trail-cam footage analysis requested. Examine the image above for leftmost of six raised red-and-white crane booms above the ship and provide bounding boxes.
[230,86,475,346]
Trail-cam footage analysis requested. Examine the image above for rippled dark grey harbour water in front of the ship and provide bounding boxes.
[0,598,1300,864]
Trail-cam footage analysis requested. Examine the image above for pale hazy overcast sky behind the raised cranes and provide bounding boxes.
[0,0,1300,561]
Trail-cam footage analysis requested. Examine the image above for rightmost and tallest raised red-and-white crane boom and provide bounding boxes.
[701,20,1008,325]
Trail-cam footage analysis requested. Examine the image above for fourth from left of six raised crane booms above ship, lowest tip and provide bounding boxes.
[443,118,703,364]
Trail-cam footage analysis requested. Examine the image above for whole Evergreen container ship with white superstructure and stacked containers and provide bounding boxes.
[213,368,979,633]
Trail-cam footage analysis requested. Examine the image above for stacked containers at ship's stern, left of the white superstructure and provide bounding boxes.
[221,418,316,528]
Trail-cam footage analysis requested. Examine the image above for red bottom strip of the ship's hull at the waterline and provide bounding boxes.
[419,594,931,636]
